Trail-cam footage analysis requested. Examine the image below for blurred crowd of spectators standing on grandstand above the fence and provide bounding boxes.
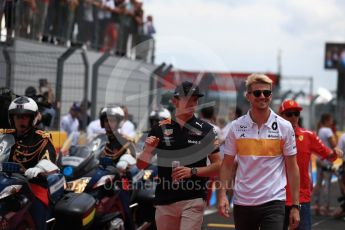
[0,0,156,59]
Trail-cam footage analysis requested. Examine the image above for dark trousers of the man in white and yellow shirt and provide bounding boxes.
[234,200,285,230]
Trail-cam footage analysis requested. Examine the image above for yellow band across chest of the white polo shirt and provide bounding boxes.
[236,138,283,157]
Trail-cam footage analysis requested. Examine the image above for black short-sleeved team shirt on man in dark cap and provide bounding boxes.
[148,116,219,205]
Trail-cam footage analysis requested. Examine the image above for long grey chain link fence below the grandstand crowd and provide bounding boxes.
[0,39,156,129]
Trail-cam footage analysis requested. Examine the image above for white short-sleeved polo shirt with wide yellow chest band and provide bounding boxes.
[224,110,296,206]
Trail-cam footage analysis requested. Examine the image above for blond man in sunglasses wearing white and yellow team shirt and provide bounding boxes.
[218,74,300,230]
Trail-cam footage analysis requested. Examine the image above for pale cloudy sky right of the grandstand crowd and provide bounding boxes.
[143,0,345,95]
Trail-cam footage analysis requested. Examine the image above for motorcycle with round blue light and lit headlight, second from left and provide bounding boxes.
[59,146,124,230]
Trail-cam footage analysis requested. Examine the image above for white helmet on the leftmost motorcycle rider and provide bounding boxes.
[8,96,38,126]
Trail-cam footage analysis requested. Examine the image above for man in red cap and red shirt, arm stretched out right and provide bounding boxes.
[279,100,343,230]
